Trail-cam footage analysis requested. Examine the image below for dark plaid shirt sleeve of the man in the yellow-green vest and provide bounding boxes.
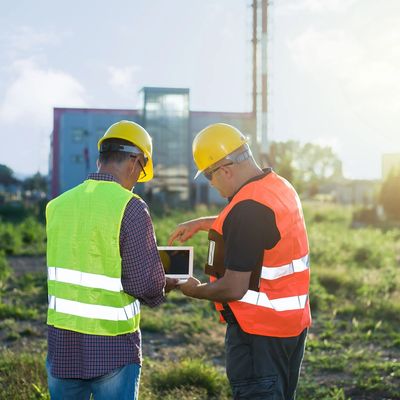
[120,197,165,307]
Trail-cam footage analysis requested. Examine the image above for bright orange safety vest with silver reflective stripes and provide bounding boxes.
[206,172,311,337]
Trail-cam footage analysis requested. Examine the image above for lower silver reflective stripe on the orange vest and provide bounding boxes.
[239,290,308,311]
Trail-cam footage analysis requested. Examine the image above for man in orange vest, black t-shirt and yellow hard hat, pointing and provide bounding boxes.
[169,123,311,400]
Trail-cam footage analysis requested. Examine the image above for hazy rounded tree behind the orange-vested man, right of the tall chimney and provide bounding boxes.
[269,140,343,195]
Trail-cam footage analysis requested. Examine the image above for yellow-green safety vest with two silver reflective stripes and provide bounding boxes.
[46,179,140,336]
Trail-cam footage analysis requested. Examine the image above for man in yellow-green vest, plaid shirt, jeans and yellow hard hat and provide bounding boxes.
[46,121,176,400]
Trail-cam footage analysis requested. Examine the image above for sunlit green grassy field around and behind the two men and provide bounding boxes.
[0,205,400,400]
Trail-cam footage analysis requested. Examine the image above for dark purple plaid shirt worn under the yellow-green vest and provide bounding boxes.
[48,173,165,379]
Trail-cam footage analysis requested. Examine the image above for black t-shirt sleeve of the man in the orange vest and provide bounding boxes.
[222,200,281,271]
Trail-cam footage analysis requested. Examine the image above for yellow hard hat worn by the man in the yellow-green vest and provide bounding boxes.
[97,120,153,182]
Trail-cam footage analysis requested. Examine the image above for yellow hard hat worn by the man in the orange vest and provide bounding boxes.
[192,123,248,179]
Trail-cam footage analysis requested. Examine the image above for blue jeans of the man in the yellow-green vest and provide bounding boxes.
[46,361,140,400]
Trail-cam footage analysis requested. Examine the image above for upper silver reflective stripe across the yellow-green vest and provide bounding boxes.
[47,267,122,292]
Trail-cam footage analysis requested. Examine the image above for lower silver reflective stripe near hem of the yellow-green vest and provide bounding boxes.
[49,296,140,321]
